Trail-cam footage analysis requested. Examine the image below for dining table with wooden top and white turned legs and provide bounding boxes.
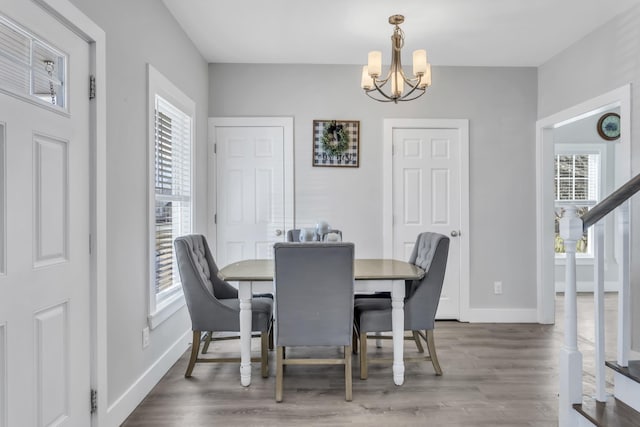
[218,259,425,387]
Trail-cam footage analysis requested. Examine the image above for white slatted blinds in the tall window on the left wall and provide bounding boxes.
[155,95,192,300]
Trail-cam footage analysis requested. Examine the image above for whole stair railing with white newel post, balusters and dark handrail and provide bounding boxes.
[559,175,640,426]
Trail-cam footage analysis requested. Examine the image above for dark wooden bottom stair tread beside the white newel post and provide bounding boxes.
[573,396,640,427]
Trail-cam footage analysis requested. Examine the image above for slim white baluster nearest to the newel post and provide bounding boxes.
[593,220,607,402]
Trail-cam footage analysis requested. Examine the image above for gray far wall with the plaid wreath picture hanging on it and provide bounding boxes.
[209,64,537,308]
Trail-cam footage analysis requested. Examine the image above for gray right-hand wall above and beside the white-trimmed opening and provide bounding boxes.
[538,6,640,350]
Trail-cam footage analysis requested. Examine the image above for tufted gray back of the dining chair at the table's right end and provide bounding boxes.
[404,232,449,330]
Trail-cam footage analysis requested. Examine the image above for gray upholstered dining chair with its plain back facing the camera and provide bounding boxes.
[274,243,354,402]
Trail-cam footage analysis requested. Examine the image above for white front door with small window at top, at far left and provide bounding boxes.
[0,0,91,427]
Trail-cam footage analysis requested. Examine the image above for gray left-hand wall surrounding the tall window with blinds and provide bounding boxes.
[72,0,208,404]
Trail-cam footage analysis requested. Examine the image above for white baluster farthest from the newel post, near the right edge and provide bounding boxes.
[617,200,631,366]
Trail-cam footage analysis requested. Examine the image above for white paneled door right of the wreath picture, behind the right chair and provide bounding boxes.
[392,128,466,319]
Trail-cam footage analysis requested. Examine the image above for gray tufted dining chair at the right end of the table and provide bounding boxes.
[354,232,449,380]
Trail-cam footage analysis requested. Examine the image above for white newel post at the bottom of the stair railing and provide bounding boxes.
[559,206,582,427]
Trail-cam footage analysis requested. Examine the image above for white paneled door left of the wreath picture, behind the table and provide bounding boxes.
[212,118,293,266]
